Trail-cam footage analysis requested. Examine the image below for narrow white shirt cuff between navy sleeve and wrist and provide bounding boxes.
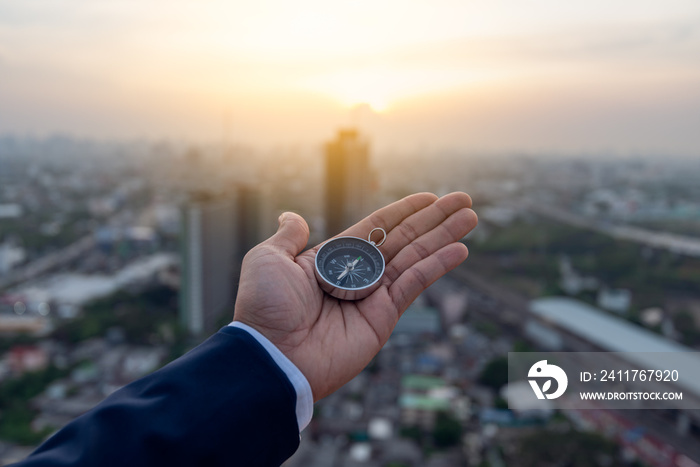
[229,321,314,432]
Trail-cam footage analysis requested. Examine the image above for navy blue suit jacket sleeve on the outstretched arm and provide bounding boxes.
[14,327,299,467]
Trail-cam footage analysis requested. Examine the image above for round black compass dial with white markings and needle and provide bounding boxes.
[316,237,384,293]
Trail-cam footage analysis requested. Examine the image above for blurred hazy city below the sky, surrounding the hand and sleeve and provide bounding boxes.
[0,133,700,467]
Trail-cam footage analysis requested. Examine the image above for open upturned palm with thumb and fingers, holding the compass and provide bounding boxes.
[234,193,477,401]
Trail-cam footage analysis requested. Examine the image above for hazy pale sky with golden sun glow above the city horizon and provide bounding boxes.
[0,0,700,155]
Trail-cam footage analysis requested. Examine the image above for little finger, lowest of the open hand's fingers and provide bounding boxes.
[389,243,469,314]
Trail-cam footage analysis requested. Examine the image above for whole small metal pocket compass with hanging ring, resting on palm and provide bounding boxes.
[316,227,386,300]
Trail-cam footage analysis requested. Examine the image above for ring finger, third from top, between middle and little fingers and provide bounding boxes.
[384,208,477,282]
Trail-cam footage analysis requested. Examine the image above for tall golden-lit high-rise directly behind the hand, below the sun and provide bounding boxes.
[325,128,373,237]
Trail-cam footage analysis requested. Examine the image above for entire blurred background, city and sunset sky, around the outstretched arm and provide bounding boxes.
[0,0,700,467]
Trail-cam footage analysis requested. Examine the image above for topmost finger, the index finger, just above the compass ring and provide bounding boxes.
[340,193,438,249]
